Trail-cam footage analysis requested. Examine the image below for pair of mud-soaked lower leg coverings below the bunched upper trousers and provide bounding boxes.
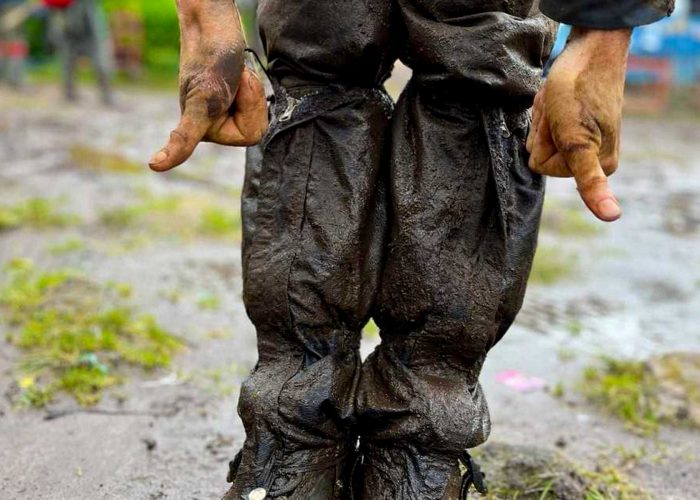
[232,79,543,500]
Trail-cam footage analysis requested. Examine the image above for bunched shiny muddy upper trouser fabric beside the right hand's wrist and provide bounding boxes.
[398,0,556,103]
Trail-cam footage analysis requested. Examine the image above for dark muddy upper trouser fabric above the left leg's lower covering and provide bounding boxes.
[258,0,402,88]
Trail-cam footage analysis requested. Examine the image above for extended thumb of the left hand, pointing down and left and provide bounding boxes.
[148,107,211,172]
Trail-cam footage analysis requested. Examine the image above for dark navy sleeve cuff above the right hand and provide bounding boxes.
[540,0,675,29]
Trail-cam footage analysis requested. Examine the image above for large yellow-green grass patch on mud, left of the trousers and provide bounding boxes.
[0,259,182,406]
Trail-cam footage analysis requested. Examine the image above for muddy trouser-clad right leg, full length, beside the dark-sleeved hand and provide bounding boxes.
[357,0,552,500]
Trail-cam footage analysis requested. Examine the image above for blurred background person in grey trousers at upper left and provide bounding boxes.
[44,0,114,105]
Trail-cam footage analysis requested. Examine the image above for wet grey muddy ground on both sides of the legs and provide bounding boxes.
[0,84,700,500]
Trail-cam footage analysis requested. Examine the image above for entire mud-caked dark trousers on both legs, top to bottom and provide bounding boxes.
[235,0,553,500]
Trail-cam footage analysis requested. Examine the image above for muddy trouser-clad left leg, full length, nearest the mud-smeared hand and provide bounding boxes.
[226,0,391,500]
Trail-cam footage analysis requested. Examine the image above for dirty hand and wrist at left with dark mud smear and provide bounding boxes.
[149,0,267,172]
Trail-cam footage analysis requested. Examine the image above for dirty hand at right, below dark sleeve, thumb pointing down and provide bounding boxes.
[527,28,631,222]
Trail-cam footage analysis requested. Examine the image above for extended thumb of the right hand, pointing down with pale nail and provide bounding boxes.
[565,149,622,222]
